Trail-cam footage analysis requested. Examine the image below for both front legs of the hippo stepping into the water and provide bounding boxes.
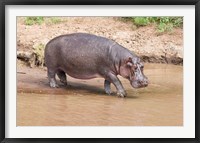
[104,73,126,97]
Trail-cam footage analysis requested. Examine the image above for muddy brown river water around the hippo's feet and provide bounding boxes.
[17,64,183,126]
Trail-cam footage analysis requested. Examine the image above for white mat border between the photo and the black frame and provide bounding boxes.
[5,5,195,138]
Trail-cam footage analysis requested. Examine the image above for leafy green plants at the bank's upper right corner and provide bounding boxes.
[123,17,183,32]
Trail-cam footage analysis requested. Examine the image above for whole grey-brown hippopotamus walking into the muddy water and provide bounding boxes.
[44,33,148,97]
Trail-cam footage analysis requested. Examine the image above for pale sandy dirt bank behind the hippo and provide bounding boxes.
[17,17,183,65]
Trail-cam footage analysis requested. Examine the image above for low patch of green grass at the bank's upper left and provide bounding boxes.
[24,16,65,25]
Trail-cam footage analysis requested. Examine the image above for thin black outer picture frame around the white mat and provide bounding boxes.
[0,0,200,143]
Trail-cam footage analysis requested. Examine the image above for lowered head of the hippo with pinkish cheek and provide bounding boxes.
[120,56,148,88]
